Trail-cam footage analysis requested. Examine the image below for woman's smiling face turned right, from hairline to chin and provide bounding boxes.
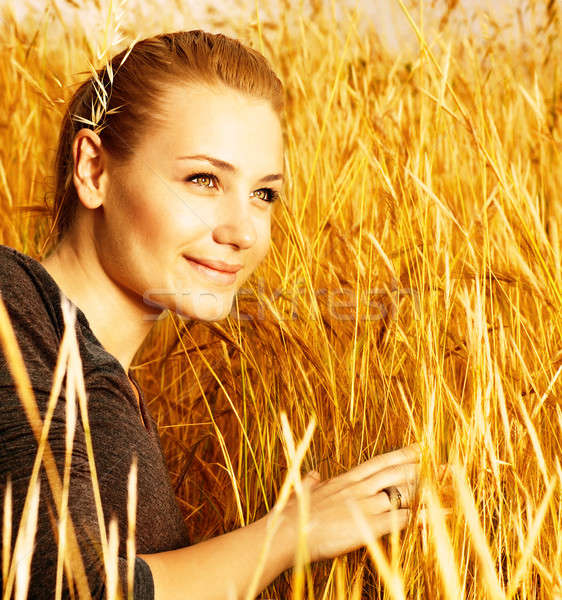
[94,85,283,320]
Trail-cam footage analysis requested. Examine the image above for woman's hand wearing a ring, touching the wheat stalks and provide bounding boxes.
[284,444,420,562]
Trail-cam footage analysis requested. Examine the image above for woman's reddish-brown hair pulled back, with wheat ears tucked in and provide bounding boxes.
[51,29,283,243]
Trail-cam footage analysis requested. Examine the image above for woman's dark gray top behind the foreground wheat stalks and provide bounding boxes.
[0,244,190,600]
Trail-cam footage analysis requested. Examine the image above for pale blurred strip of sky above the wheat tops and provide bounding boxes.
[0,0,544,52]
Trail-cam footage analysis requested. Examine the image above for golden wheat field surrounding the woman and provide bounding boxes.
[0,0,562,600]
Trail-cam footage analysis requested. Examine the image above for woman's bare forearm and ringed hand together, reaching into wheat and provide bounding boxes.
[139,446,419,600]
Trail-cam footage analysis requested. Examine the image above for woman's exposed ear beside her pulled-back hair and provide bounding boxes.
[72,128,107,208]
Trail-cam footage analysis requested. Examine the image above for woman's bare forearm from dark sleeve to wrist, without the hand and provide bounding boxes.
[138,513,295,600]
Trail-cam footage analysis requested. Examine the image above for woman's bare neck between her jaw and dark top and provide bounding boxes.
[40,234,156,372]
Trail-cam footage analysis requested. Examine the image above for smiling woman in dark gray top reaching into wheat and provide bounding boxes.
[0,31,418,600]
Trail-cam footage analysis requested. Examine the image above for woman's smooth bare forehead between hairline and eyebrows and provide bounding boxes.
[146,84,283,171]
